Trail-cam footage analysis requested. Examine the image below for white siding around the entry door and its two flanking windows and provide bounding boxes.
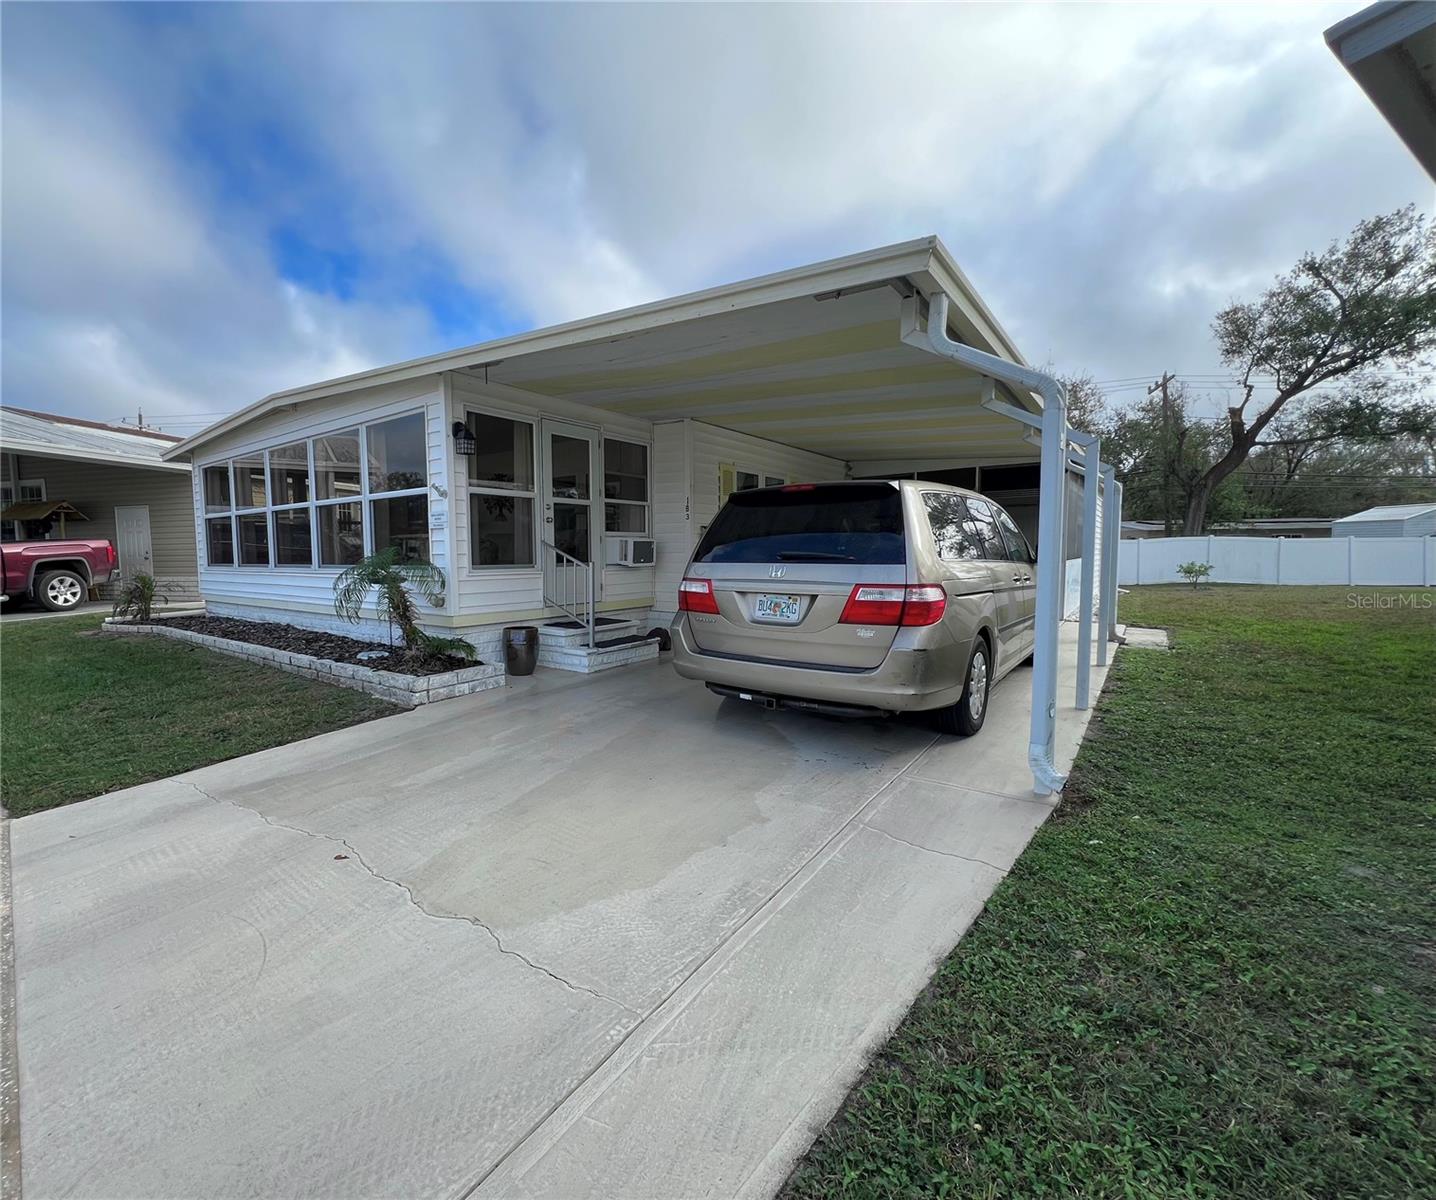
[448,375,658,622]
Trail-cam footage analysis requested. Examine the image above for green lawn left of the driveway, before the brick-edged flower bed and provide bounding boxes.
[0,616,401,817]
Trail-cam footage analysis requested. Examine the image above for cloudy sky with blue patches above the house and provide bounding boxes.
[0,0,1433,433]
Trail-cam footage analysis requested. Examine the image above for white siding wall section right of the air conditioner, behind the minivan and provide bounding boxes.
[653,421,847,623]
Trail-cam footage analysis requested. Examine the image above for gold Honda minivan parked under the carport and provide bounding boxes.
[672,479,1037,733]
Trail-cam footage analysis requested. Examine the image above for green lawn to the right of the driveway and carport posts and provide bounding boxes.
[785,587,1436,1200]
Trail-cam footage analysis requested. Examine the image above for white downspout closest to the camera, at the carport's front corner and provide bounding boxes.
[902,291,1067,795]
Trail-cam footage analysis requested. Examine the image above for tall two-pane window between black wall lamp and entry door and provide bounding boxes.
[465,412,537,567]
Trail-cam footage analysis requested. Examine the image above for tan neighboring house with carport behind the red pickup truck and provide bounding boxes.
[0,408,198,600]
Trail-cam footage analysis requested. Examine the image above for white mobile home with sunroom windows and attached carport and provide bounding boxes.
[168,238,1097,669]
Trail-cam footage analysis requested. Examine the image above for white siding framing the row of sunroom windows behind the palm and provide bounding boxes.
[192,376,452,619]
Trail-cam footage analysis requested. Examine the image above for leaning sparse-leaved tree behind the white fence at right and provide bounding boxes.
[1185,207,1436,534]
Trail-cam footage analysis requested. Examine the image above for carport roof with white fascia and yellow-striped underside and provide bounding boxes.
[167,237,1040,462]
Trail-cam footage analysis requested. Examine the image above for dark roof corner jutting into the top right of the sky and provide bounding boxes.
[1325,0,1436,179]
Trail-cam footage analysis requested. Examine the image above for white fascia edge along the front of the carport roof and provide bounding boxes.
[164,237,1035,459]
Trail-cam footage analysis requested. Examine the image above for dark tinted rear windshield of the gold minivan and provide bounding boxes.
[694,484,908,563]
